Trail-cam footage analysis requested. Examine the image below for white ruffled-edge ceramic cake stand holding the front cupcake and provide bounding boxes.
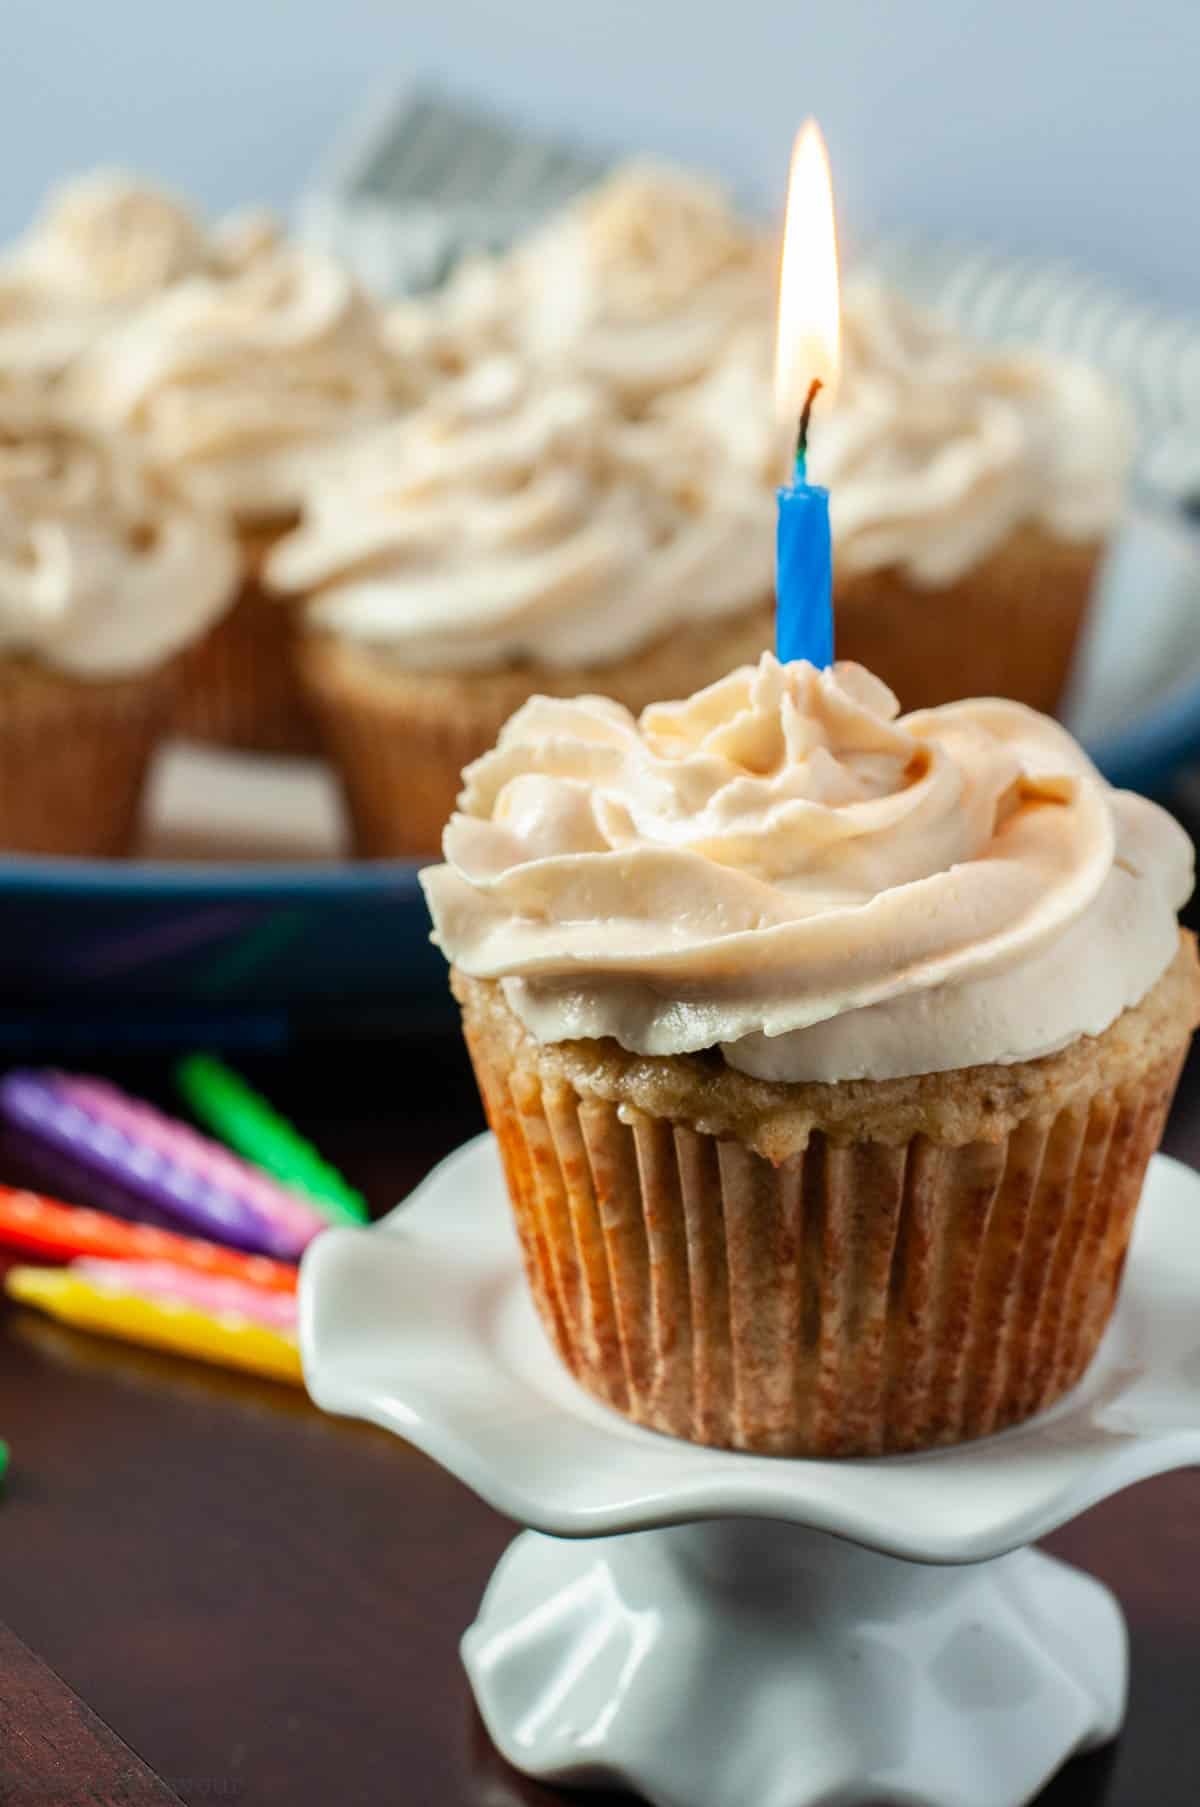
[300,1137,1200,1807]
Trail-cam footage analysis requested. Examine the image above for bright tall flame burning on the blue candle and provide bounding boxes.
[775,119,840,434]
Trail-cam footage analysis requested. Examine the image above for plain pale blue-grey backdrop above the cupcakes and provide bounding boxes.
[0,0,1200,309]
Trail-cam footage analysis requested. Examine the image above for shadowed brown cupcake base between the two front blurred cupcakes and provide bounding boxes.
[172,529,320,754]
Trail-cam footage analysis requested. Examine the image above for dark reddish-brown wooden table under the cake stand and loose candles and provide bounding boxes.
[0,1035,1200,1807]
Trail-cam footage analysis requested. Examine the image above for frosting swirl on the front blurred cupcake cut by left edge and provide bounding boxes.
[0,398,237,678]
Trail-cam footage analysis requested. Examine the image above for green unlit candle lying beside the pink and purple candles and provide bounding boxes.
[175,1053,369,1223]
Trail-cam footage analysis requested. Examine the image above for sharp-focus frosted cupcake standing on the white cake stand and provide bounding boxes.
[423,654,1200,1456]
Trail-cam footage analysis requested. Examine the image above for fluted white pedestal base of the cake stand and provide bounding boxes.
[463,1520,1128,1807]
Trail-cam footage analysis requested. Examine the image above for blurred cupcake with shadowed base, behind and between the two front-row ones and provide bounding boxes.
[69,235,399,752]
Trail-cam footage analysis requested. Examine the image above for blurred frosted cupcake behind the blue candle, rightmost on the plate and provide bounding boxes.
[660,282,1130,710]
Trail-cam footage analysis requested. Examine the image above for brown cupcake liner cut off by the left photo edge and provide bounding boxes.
[0,658,179,858]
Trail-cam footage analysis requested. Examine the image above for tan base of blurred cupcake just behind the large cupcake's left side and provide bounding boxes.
[298,600,773,858]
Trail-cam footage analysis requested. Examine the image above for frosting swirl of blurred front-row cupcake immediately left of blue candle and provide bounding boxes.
[266,356,773,670]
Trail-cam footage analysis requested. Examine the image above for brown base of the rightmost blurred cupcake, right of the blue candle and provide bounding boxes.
[835,524,1102,716]
